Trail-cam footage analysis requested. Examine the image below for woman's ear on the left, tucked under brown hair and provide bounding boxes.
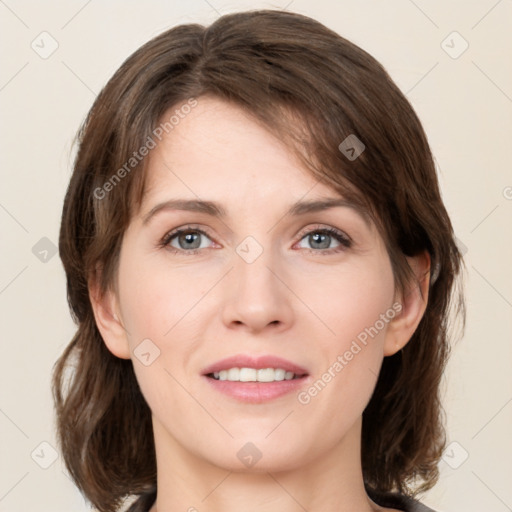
[89,272,130,359]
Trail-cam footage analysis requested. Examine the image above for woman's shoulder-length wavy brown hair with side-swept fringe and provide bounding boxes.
[53,10,464,512]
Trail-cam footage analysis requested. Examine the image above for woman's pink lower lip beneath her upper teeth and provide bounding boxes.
[204,376,307,404]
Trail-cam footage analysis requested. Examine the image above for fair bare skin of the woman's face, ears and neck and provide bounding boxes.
[90,97,429,512]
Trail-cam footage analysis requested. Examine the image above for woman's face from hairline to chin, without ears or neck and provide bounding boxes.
[104,97,401,470]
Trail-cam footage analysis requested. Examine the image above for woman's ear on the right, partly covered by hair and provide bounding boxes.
[384,251,430,356]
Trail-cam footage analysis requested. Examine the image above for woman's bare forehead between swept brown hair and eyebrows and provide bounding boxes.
[143,97,339,205]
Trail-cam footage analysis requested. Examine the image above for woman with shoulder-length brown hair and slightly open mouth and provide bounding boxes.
[53,11,463,512]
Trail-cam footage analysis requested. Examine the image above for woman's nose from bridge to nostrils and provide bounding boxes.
[222,239,294,333]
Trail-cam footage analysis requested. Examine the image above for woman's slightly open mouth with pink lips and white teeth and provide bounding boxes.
[202,355,309,403]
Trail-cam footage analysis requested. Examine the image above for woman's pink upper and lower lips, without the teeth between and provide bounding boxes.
[202,354,310,404]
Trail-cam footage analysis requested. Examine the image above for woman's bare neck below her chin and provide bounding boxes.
[146,418,383,512]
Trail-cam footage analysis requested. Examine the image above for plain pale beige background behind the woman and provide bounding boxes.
[0,0,512,512]
